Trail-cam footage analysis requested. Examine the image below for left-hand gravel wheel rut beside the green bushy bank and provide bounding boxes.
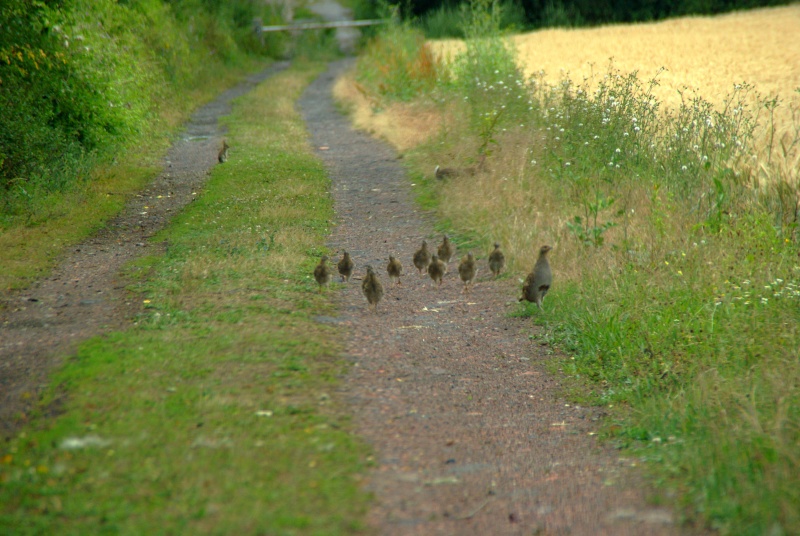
[0,62,288,437]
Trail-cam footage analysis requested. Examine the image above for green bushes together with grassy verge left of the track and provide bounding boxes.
[0,0,286,288]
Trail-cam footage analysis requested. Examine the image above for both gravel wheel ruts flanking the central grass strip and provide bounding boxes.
[0,53,704,535]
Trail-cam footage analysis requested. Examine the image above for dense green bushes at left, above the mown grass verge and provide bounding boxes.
[0,0,288,214]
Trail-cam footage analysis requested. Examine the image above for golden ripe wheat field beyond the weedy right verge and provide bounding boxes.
[431,4,800,129]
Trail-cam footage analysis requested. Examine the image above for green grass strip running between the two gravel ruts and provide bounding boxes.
[0,60,369,535]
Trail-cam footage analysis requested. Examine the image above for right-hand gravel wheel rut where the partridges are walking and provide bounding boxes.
[300,62,692,535]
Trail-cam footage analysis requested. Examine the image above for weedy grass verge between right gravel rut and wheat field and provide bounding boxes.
[355,0,800,534]
